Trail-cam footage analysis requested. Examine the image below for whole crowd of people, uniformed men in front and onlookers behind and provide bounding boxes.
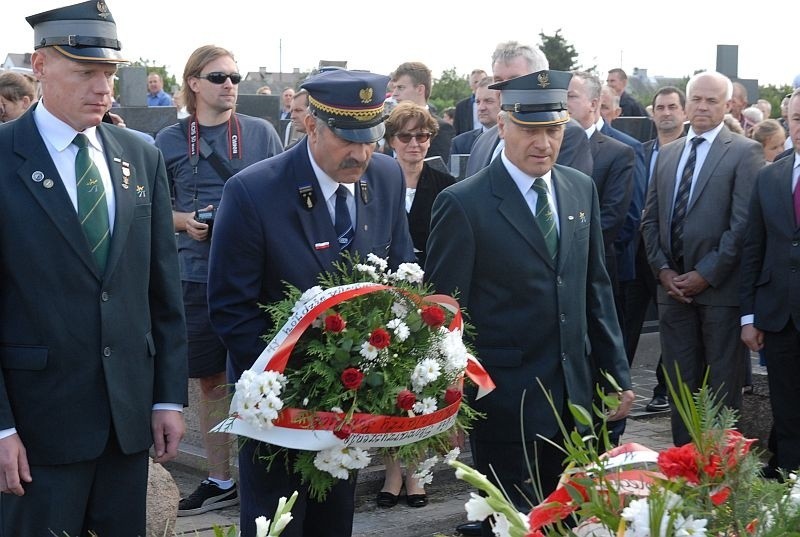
[0,0,800,537]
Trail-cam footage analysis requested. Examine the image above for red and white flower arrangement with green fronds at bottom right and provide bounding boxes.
[450,376,800,537]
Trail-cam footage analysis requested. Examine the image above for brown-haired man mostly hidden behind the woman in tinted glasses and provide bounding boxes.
[392,62,455,166]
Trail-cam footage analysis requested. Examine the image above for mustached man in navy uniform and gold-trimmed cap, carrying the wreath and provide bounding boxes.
[208,69,414,537]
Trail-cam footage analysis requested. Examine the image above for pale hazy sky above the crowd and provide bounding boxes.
[0,0,800,85]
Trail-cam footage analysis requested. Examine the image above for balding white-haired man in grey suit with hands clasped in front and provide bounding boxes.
[642,72,764,445]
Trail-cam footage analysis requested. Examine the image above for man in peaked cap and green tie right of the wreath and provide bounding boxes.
[426,71,633,535]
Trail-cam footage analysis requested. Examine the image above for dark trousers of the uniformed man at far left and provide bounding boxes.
[0,431,148,537]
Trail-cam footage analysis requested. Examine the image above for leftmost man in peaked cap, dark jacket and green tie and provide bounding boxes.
[0,1,187,537]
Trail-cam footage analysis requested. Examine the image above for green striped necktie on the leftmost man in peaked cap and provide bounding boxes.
[72,133,111,272]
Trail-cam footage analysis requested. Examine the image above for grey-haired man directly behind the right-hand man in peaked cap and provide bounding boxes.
[467,41,592,177]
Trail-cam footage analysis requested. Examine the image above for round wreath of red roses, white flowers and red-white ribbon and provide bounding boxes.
[214,254,494,499]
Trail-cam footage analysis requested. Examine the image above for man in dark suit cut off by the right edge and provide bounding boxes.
[741,90,800,471]
